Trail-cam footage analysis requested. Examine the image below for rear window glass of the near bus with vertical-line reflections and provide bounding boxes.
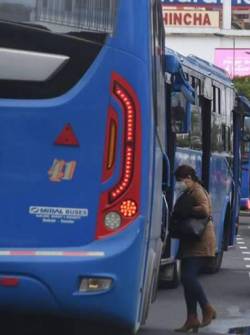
[0,0,117,34]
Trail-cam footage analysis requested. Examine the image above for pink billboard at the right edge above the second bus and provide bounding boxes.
[215,49,250,78]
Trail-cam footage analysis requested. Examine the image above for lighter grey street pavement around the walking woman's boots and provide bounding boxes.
[139,217,250,335]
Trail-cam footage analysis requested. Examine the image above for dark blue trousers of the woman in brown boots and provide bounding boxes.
[181,257,208,315]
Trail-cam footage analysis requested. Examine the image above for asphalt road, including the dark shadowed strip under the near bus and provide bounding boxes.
[0,213,250,335]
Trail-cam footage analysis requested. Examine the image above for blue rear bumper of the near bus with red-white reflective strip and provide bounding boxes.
[0,218,144,325]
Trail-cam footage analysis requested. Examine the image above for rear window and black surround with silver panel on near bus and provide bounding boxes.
[0,0,118,99]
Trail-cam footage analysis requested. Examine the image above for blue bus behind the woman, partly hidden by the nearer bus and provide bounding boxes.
[160,49,250,287]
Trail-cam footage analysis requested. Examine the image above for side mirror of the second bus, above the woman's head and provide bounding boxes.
[171,91,192,134]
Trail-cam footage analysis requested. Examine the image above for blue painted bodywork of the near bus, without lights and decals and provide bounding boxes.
[0,0,166,329]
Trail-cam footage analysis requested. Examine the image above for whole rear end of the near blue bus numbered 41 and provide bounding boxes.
[0,0,153,328]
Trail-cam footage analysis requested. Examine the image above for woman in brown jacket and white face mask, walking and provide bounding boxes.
[172,165,216,332]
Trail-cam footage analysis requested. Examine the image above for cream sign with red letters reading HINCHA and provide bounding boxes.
[163,7,220,28]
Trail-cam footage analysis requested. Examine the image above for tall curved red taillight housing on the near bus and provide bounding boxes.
[96,73,141,238]
